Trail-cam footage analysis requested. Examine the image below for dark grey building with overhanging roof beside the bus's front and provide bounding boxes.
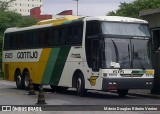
[140,8,160,94]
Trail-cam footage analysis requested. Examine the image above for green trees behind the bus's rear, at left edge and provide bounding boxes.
[0,0,37,69]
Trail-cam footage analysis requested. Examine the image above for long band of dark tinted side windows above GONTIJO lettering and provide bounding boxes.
[4,22,83,49]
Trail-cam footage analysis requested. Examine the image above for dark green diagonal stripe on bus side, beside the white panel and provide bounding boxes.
[50,47,71,85]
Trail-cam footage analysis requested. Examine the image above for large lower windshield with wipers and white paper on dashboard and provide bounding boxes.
[102,38,152,69]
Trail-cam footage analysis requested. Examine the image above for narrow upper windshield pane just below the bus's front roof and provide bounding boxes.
[101,22,150,37]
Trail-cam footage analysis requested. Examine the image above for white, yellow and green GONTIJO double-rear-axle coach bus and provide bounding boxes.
[3,16,154,96]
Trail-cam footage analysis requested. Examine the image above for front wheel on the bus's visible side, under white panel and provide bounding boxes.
[76,74,86,97]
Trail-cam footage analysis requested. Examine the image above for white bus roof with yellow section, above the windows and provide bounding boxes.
[5,16,148,33]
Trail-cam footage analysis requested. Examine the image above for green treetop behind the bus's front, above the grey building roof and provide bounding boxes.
[107,0,160,18]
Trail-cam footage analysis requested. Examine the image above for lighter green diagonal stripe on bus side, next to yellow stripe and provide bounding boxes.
[42,48,60,84]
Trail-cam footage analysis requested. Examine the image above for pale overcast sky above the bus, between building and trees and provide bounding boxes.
[42,0,134,16]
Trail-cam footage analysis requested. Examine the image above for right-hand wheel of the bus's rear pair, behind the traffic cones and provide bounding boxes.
[23,71,30,90]
